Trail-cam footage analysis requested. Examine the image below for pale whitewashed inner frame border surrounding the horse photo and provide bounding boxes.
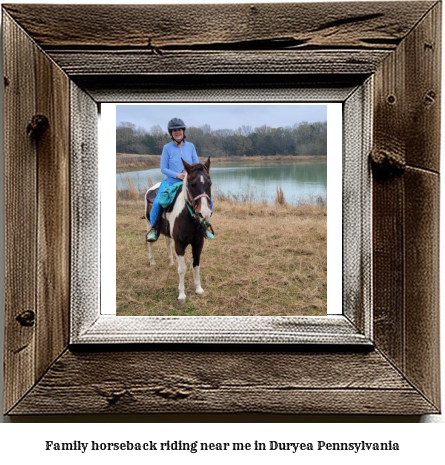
[70,81,373,345]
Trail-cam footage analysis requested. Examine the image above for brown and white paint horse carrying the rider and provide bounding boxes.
[145,157,212,303]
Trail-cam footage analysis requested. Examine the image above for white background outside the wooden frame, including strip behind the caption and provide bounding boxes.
[0,0,445,458]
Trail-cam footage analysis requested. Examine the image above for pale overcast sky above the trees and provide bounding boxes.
[116,104,327,132]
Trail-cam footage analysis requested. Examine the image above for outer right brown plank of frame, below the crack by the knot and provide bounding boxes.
[404,169,440,406]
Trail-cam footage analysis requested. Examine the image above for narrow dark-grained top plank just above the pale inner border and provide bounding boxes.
[49,50,391,78]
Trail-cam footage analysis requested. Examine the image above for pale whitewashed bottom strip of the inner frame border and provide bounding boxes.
[71,316,371,347]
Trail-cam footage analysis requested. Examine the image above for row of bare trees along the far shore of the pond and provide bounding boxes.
[116,121,327,157]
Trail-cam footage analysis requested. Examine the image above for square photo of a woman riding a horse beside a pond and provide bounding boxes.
[113,104,330,316]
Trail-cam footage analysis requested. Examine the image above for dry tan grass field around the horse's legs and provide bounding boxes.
[116,194,327,316]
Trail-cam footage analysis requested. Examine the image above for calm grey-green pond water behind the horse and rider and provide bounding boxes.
[116,161,327,204]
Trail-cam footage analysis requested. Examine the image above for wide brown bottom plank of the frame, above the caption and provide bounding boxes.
[11,350,435,415]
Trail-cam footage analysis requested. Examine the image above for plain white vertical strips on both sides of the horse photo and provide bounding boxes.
[103,103,343,318]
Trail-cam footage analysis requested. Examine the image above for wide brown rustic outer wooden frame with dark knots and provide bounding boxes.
[2,1,441,415]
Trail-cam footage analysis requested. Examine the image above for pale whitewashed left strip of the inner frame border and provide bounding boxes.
[70,83,100,340]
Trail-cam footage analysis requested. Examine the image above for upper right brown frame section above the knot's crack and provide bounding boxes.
[373,3,441,172]
